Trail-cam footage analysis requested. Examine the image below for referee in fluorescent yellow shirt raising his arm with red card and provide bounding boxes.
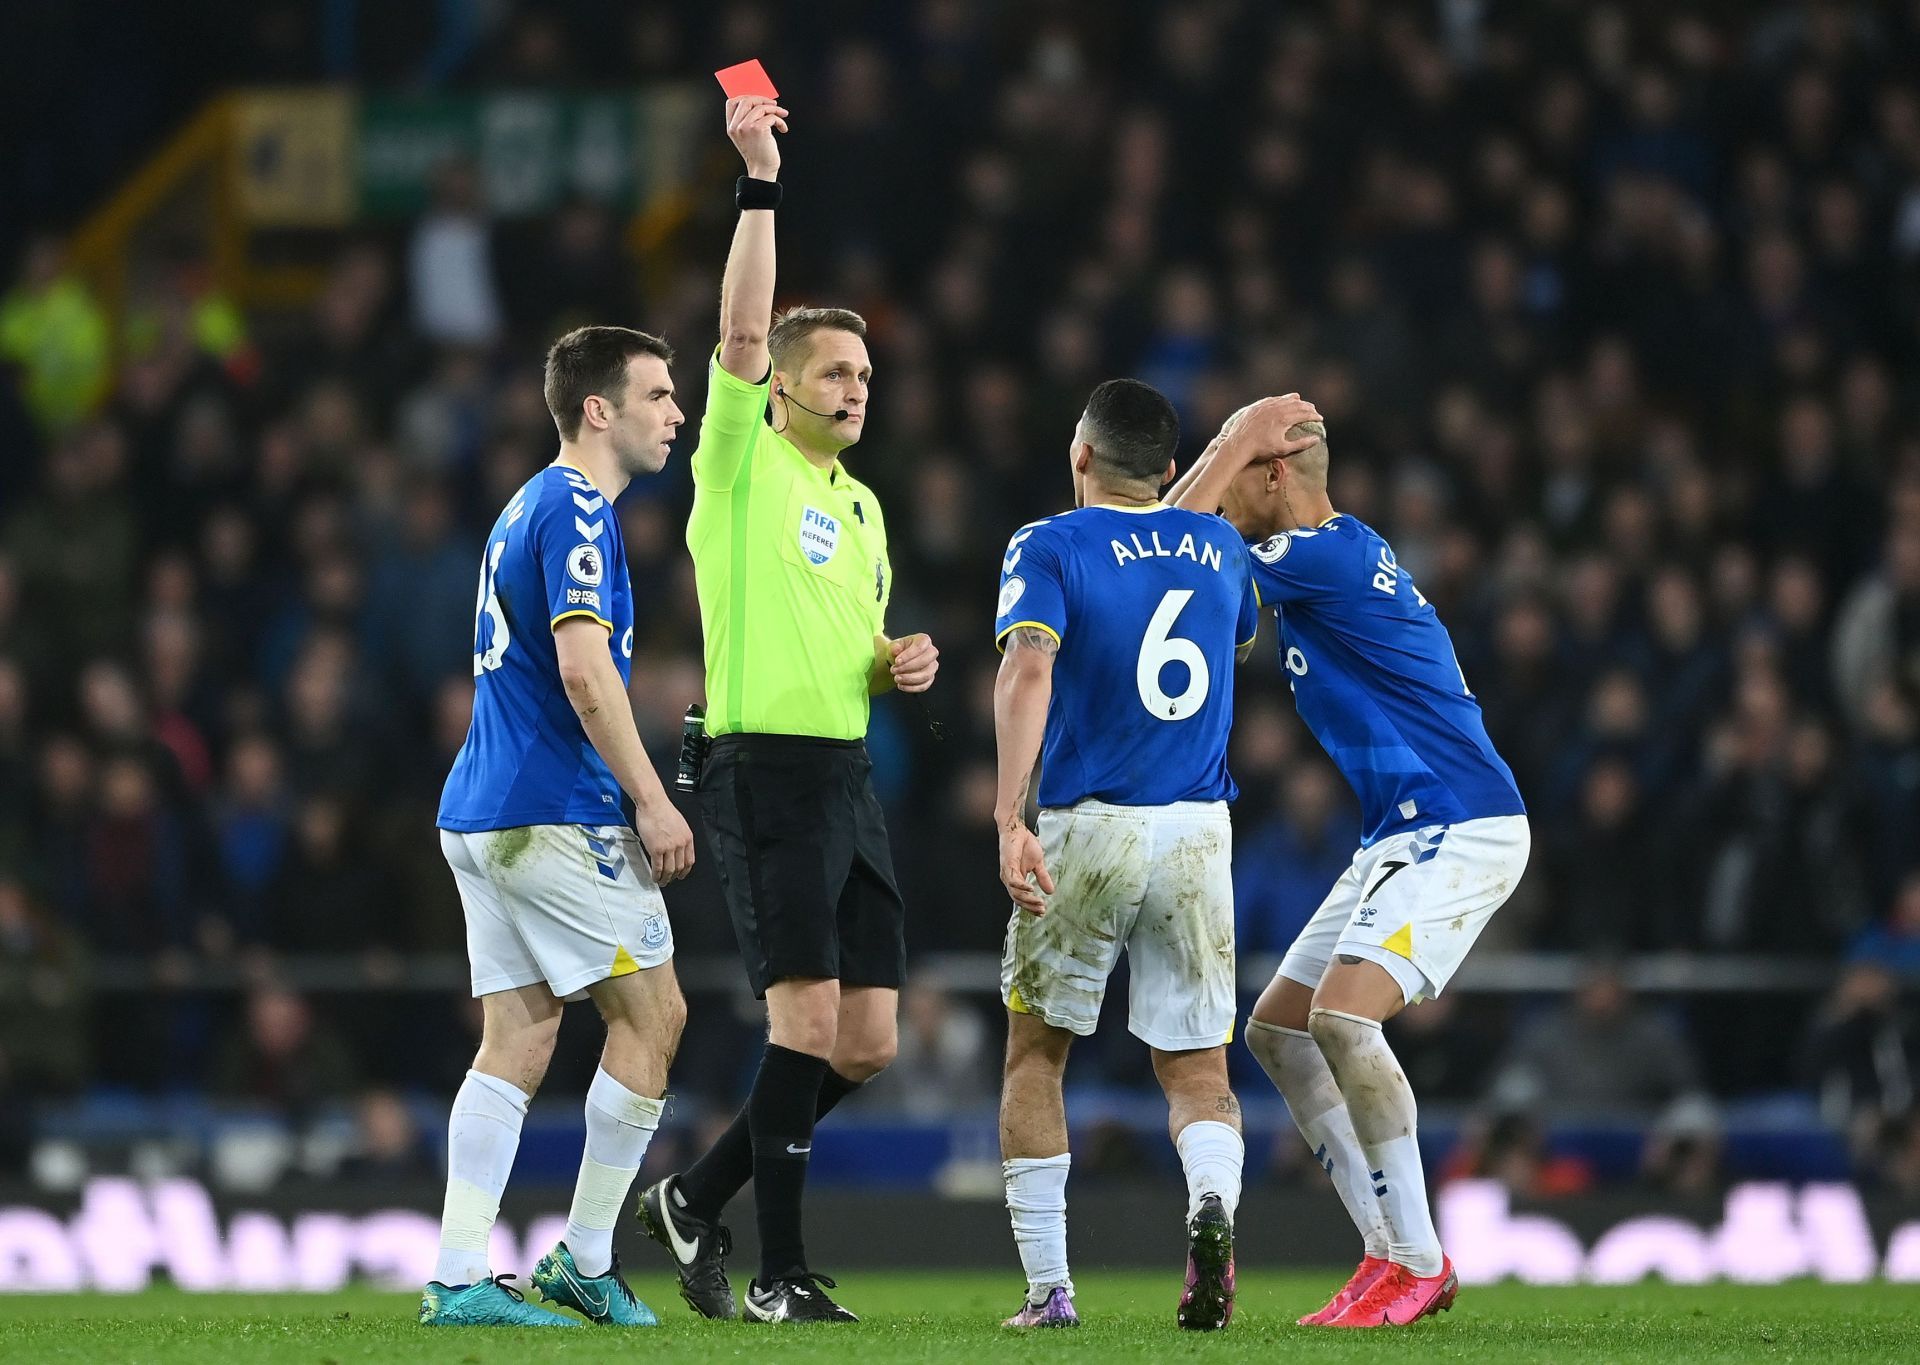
[641,96,939,1323]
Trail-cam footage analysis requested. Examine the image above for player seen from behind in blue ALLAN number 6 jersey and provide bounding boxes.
[993,380,1317,1329]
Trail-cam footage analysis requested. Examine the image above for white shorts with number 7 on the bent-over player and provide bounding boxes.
[1279,816,1532,1004]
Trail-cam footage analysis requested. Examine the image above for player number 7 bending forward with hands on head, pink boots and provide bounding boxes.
[1173,397,1530,1327]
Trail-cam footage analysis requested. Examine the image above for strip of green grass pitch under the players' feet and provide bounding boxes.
[0,1271,1920,1365]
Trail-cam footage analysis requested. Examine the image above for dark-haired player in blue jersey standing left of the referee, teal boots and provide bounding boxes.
[420,326,693,1327]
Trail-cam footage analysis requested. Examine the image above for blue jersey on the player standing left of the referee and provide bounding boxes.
[440,465,634,831]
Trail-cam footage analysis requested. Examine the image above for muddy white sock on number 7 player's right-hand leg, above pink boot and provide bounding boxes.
[1308,1010,1442,1275]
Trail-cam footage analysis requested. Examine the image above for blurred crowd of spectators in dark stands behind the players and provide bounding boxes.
[0,0,1920,1190]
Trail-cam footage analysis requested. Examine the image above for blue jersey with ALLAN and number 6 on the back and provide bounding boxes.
[995,503,1260,806]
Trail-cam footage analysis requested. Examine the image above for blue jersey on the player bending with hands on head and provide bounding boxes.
[1252,516,1526,849]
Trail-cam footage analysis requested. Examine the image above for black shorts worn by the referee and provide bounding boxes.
[701,735,906,996]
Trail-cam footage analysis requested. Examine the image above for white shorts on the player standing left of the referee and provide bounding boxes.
[440,826,674,996]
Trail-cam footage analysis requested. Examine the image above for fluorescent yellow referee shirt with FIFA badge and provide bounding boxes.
[687,347,893,739]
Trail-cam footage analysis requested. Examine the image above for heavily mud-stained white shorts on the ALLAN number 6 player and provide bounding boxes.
[1000,801,1235,1052]
